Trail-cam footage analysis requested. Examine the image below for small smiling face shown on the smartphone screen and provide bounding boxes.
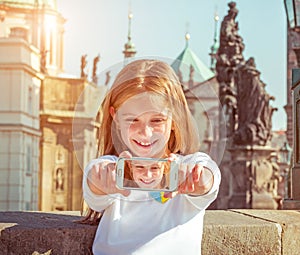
[130,160,164,189]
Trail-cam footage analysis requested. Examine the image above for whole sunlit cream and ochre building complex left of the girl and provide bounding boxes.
[0,0,105,211]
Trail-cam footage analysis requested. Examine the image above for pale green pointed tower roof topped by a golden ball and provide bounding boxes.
[172,34,214,82]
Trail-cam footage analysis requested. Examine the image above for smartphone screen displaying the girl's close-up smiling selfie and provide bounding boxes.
[123,159,171,190]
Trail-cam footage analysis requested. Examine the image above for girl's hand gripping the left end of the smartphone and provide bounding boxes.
[87,161,130,196]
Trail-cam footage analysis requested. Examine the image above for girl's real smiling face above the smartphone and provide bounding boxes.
[112,92,172,158]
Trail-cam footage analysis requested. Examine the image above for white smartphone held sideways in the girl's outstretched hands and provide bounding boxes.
[116,157,178,192]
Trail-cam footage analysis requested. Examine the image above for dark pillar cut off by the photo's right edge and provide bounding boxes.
[283,68,300,209]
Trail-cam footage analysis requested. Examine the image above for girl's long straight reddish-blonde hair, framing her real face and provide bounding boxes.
[82,59,200,223]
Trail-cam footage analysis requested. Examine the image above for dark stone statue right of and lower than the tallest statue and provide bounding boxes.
[233,58,275,145]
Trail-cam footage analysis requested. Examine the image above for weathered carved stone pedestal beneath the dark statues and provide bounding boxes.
[228,145,280,209]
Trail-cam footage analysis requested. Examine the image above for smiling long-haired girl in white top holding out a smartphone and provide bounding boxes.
[83,60,221,255]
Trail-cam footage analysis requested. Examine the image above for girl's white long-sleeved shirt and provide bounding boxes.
[83,152,221,255]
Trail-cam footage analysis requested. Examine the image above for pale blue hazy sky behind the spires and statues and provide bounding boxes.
[57,0,287,130]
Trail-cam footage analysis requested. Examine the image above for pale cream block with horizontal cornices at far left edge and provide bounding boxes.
[0,37,43,210]
